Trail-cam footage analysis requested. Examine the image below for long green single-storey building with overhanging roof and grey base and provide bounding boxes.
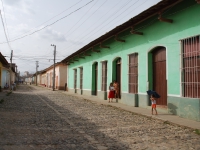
[62,0,200,121]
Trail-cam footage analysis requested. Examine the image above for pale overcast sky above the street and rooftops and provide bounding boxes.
[0,0,160,75]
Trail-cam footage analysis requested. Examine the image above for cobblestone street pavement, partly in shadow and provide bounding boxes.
[0,85,200,150]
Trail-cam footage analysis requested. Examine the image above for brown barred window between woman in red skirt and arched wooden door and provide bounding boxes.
[128,53,138,93]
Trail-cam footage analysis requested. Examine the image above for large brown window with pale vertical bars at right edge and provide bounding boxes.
[181,36,200,98]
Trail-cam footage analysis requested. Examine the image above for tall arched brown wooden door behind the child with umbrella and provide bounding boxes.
[153,47,167,105]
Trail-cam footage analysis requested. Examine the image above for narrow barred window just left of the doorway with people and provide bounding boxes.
[101,61,107,91]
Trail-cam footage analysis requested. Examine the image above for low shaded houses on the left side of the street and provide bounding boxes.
[0,52,18,88]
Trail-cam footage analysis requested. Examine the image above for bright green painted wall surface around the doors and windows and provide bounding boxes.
[68,1,200,95]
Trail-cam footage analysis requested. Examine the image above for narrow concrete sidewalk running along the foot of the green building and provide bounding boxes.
[63,92,200,130]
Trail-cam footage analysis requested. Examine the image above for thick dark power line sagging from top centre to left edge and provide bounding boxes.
[0,0,94,44]
